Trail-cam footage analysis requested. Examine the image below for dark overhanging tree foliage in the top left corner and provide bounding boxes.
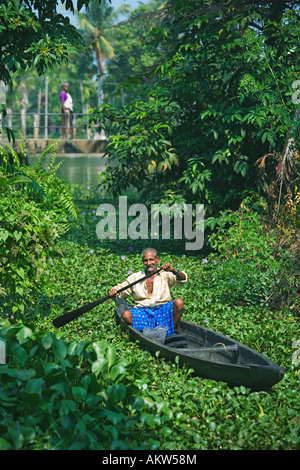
[0,0,89,85]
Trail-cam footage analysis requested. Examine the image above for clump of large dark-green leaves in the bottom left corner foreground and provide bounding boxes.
[0,324,173,450]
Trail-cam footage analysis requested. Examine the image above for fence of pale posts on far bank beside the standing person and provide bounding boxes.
[2,112,105,139]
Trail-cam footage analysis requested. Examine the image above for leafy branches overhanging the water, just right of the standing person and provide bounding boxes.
[90,89,180,200]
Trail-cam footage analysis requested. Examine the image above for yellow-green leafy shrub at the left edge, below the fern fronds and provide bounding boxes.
[0,188,59,313]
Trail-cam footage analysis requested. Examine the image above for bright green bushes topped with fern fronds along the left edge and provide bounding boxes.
[0,140,77,314]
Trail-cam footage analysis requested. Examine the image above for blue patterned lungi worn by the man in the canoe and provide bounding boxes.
[130,300,175,336]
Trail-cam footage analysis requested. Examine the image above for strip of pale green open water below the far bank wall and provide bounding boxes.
[28,155,107,188]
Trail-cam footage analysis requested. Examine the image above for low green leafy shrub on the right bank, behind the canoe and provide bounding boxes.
[206,208,279,304]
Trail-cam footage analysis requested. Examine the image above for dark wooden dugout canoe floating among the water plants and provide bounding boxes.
[116,298,285,391]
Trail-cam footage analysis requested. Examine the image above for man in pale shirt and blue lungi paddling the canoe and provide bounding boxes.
[109,248,187,336]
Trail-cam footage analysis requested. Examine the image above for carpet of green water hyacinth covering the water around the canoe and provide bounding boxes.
[0,188,299,451]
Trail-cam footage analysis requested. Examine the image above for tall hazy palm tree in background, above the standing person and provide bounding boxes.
[76,0,131,106]
